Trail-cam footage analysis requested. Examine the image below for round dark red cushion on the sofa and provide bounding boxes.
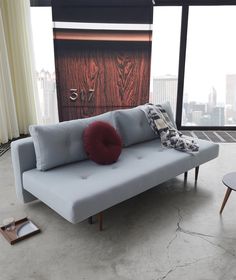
[83,121,122,164]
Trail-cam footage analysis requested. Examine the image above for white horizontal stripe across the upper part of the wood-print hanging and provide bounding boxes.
[53,21,152,31]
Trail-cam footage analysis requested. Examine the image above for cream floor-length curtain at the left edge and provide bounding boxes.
[0,0,40,143]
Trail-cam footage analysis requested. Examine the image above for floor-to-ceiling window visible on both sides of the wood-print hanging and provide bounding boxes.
[31,0,236,129]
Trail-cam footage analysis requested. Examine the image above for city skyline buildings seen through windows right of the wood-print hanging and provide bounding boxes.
[150,74,236,126]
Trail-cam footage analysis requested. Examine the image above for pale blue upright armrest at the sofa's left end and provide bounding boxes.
[11,137,36,203]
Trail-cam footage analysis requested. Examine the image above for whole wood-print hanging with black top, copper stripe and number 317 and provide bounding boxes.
[52,0,153,121]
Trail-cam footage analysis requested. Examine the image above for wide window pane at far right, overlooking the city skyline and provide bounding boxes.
[182,6,236,126]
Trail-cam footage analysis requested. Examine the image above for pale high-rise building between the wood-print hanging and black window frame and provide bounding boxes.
[150,75,178,117]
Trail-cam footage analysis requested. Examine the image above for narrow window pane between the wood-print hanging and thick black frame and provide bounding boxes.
[150,7,181,117]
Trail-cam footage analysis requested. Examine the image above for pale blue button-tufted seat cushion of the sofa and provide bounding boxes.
[23,139,219,223]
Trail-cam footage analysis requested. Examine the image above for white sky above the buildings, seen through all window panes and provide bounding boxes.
[31,6,236,104]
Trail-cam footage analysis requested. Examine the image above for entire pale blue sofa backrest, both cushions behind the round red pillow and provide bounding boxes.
[29,103,173,171]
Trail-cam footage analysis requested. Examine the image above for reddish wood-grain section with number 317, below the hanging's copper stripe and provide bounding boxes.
[56,42,150,120]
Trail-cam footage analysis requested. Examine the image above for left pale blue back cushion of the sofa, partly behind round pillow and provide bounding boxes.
[29,112,115,171]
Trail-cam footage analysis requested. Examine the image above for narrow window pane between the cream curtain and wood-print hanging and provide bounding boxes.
[31,7,58,124]
